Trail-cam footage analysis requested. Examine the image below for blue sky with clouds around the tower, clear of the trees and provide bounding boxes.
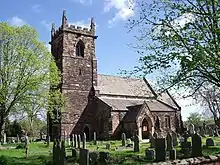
[0,0,198,119]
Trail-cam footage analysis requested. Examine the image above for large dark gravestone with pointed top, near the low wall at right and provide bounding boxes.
[192,133,202,157]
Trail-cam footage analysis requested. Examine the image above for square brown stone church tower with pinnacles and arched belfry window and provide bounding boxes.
[49,11,97,138]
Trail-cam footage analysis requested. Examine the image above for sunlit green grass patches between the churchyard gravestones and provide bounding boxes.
[0,137,220,165]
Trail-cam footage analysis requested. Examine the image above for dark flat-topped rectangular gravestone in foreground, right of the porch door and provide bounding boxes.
[155,138,166,162]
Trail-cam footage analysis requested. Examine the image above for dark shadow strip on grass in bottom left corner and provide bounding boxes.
[0,155,51,165]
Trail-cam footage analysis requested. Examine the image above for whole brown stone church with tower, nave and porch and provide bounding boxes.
[48,11,182,139]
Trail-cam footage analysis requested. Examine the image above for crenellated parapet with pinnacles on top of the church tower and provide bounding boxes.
[51,10,95,39]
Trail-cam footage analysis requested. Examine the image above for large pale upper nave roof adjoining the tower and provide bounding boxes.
[95,74,154,98]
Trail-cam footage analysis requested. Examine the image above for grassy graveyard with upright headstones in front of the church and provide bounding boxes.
[0,134,220,165]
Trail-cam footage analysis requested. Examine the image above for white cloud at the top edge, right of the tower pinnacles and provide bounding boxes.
[104,0,134,25]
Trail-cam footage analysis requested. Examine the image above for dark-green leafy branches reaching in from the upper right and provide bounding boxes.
[128,0,220,95]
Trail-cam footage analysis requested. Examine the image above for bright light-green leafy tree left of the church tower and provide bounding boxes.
[0,23,62,142]
